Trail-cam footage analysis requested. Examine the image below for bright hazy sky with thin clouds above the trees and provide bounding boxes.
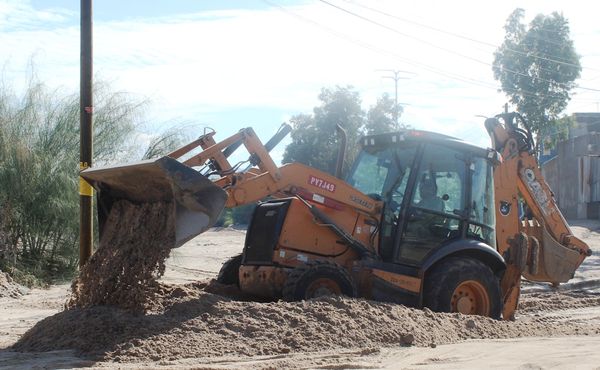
[0,0,600,159]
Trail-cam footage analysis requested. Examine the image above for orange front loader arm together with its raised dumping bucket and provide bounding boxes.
[80,124,383,252]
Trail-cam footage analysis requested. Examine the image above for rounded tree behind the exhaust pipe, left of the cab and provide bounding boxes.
[283,86,365,174]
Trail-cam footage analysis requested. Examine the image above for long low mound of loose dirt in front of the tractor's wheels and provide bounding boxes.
[14,283,600,362]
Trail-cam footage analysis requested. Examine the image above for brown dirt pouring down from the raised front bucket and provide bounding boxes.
[67,201,175,312]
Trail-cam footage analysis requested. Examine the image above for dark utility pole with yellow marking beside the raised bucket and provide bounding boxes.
[79,0,94,268]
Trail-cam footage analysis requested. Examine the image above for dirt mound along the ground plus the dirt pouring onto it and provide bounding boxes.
[13,198,600,363]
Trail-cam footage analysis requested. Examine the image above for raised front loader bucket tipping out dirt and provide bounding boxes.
[80,157,227,248]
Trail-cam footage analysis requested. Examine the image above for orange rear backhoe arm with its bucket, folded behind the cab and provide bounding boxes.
[485,113,591,319]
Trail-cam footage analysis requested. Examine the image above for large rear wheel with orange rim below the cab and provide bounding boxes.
[423,257,502,319]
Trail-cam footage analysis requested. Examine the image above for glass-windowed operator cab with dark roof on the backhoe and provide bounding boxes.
[347,130,498,267]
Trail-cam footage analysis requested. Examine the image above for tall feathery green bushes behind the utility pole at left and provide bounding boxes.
[0,81,145,280]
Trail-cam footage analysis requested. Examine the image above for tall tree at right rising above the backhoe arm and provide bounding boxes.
[493,9,581,149]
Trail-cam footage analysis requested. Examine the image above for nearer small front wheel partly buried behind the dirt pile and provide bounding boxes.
[282,261,356,301]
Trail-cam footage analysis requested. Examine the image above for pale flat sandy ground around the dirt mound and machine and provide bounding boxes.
[0,220,600,369]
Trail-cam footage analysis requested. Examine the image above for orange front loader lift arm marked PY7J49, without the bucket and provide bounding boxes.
[168,124,382,216]
